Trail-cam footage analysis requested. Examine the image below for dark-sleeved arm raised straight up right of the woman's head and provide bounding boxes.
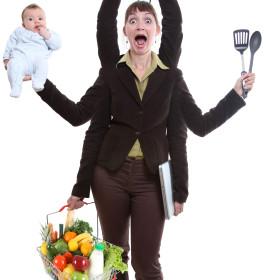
[159,0,183,68]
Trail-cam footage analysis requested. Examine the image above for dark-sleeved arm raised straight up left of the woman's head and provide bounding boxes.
[96,0,121,67]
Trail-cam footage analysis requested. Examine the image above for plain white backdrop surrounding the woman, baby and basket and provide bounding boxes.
[0,0,280,280]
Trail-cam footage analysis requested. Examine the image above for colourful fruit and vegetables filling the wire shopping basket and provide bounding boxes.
[40,213,127,280]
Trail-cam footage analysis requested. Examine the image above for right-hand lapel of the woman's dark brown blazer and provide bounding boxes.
[142,68,168,104]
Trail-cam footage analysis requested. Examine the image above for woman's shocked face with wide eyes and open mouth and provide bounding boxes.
[124,10,160,55]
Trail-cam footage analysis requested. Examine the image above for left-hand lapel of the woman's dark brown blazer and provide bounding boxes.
[117,66,142,104]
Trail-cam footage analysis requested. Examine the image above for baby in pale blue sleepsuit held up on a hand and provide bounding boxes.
[3,4,60,97]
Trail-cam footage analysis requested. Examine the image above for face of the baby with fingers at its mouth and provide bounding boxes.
[22,9,46,33]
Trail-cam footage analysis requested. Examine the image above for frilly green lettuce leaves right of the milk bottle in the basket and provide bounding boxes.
[104,244,128,273]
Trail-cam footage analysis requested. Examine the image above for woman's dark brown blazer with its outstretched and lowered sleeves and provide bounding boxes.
[36,0,244,202]
